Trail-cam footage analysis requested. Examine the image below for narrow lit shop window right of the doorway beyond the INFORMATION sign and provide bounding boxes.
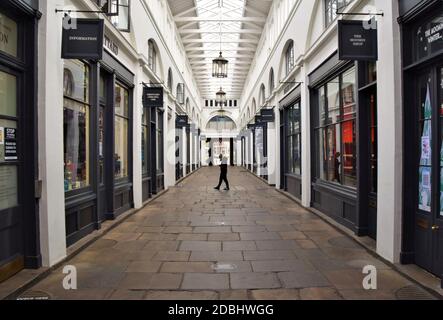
[114,84,129,179]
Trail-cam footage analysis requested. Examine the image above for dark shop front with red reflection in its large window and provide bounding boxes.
[309,54,377,238]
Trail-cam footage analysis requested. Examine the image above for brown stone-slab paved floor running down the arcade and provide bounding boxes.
[24,168,438,300]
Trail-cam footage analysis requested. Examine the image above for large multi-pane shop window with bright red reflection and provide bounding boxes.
[315,68,357,188]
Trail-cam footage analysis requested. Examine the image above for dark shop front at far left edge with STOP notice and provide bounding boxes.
[0,0,41,282]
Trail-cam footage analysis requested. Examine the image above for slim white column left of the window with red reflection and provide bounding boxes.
[301,72,314,207]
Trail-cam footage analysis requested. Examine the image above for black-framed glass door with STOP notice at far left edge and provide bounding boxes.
[0,67,24,282]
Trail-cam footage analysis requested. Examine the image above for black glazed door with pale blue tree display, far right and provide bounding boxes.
[415,68,443,276]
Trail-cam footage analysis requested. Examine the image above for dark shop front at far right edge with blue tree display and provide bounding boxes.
[400,1,443,278]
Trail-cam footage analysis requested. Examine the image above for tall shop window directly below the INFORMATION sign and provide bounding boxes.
[63,60,90,192]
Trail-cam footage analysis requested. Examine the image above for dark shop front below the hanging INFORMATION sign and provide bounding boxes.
[63,47,134,246]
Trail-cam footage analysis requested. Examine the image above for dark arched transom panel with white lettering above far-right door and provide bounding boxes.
[414,16,443,60]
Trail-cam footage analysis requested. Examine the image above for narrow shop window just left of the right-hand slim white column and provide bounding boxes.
[286,102,301,175]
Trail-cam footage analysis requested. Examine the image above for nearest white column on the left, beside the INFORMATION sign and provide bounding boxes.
[38,0,66,267]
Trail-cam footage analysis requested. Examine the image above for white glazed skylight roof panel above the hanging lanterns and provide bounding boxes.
[168,0,272,99]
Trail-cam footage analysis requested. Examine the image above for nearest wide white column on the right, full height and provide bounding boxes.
[375,0,403,262]
